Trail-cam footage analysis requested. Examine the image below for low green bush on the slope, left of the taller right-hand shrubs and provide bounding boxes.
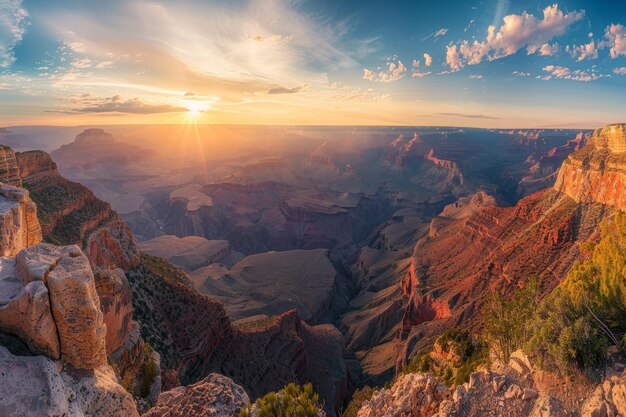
[402,328,489,386]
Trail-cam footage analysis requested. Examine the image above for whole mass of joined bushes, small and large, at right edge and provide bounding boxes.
[472,212,626,378]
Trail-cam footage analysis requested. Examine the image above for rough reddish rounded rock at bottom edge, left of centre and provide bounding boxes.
[143,374,250,417]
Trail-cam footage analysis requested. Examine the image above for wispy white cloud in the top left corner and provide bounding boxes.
[0,0,28,68]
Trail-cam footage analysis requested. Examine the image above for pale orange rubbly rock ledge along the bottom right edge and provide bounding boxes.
[358,351,626,417]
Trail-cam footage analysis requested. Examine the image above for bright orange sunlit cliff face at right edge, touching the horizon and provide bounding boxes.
[554,124,626,210]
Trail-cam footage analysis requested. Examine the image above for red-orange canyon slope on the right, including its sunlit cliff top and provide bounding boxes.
[399,125,626,366]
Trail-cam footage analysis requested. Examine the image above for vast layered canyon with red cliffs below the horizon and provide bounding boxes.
[0,125,626,416]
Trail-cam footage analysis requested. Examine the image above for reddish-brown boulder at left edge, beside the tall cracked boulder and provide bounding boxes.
[0,258,60,359]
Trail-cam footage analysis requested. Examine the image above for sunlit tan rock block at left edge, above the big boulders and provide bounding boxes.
[0,183,42,256]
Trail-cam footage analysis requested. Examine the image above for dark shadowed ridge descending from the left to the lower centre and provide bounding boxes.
[128,255,347,410]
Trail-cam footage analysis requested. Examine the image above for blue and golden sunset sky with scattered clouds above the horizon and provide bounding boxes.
[0,0,626,128]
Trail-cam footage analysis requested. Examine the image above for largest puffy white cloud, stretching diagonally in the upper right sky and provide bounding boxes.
[446,4,585,71]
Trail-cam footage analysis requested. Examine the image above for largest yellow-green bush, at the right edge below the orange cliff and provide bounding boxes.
[527,212,626,373]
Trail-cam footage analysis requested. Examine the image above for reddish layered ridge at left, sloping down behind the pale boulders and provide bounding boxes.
[0,147,139,270]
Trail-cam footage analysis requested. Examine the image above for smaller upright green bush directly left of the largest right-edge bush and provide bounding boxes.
[484,278,539,363]
